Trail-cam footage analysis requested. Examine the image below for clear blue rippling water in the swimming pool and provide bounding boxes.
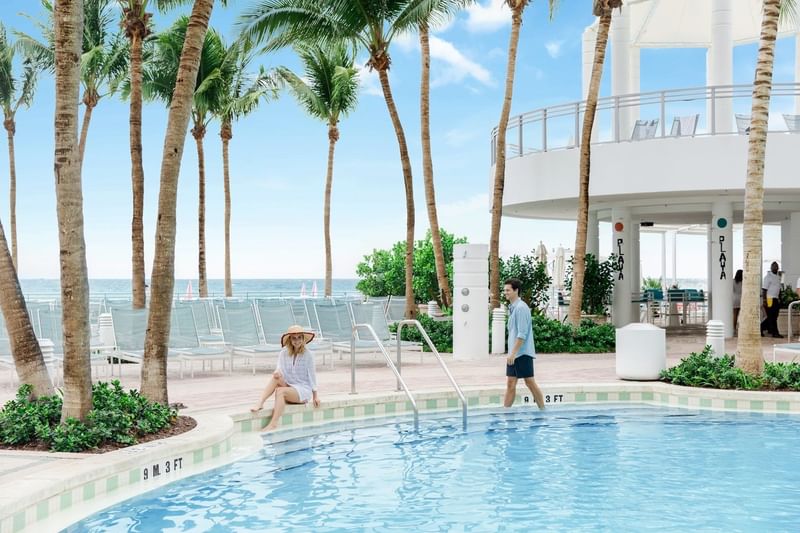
[67,406,800,532]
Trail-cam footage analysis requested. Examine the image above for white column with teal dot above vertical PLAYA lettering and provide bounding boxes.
[708,202,736,337]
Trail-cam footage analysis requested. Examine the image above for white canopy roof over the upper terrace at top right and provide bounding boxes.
[622,0,800,48]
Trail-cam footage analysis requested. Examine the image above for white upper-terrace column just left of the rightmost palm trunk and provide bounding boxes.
[707,0,733,132]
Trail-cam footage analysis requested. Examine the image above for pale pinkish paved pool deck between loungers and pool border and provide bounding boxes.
[0,336,786,496]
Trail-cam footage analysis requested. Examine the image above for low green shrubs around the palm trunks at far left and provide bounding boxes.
[0,380,178,452]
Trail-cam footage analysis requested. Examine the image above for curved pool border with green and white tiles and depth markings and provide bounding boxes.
[0,382,800,533]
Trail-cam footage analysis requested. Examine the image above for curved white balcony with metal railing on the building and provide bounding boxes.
[491,83,800,222]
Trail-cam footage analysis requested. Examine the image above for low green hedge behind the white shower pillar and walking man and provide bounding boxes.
[392,314,616,353]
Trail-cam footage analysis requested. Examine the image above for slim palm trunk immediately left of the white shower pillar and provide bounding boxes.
[419,24,452,307]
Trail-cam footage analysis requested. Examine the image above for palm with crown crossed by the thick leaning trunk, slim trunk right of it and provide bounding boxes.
[143,17,228,298]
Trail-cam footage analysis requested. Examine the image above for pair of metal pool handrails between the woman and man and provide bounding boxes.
[350,320,467,431]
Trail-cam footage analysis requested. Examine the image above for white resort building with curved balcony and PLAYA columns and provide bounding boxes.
[492,0,800,336]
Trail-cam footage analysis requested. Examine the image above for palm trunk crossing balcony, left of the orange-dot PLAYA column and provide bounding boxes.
[567,9,611,328]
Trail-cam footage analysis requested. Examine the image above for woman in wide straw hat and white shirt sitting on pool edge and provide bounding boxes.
[250,326,319,431]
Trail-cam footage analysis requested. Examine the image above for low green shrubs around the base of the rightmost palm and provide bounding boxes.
[661,346,800,391]
